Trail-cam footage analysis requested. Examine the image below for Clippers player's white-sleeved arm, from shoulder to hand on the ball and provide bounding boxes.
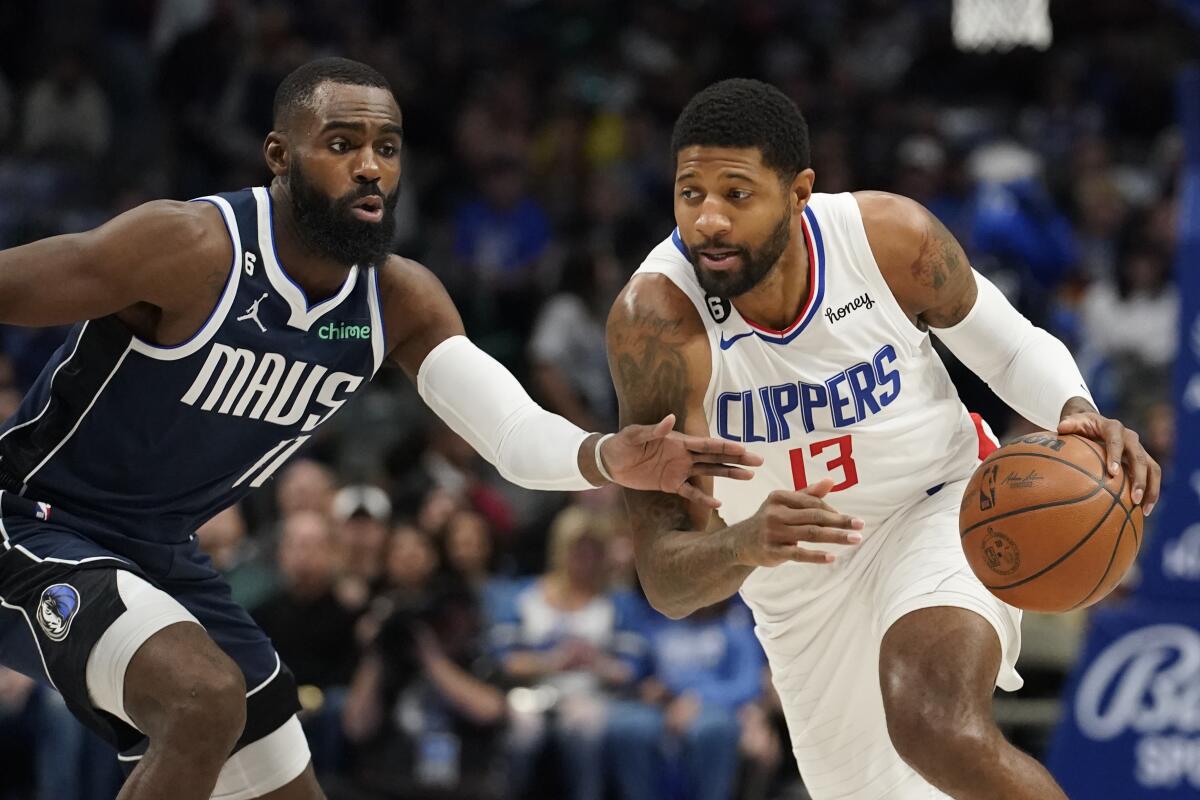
[856,192,1162,513]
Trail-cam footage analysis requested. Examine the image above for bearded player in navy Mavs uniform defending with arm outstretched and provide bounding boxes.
[0,59,758,800]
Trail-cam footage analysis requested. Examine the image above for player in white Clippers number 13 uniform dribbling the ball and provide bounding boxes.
[608,80,1159,800]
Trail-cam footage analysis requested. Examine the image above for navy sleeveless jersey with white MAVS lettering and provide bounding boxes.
[0,187,384,543]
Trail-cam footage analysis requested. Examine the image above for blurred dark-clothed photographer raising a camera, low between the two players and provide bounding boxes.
[344,588,505,800]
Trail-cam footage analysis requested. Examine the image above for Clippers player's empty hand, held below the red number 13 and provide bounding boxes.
[734,479,863,566]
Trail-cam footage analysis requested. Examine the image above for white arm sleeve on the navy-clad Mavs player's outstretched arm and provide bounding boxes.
[416,336,595,492]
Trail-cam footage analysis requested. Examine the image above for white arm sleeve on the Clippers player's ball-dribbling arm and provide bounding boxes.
[930,272,1096,431]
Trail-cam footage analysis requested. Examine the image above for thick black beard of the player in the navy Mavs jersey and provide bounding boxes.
[288,158,400,266]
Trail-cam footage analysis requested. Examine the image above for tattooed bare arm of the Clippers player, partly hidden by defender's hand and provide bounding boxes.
[607,275,862,619]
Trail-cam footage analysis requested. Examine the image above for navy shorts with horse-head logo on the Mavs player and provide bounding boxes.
[0,492,300,763]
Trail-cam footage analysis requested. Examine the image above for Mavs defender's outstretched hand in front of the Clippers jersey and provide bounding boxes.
[600,414,762,509]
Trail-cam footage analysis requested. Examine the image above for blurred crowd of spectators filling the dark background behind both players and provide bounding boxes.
[0,0,1198,800]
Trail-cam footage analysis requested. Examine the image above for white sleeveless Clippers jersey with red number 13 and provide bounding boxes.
[637,193,979,624]
